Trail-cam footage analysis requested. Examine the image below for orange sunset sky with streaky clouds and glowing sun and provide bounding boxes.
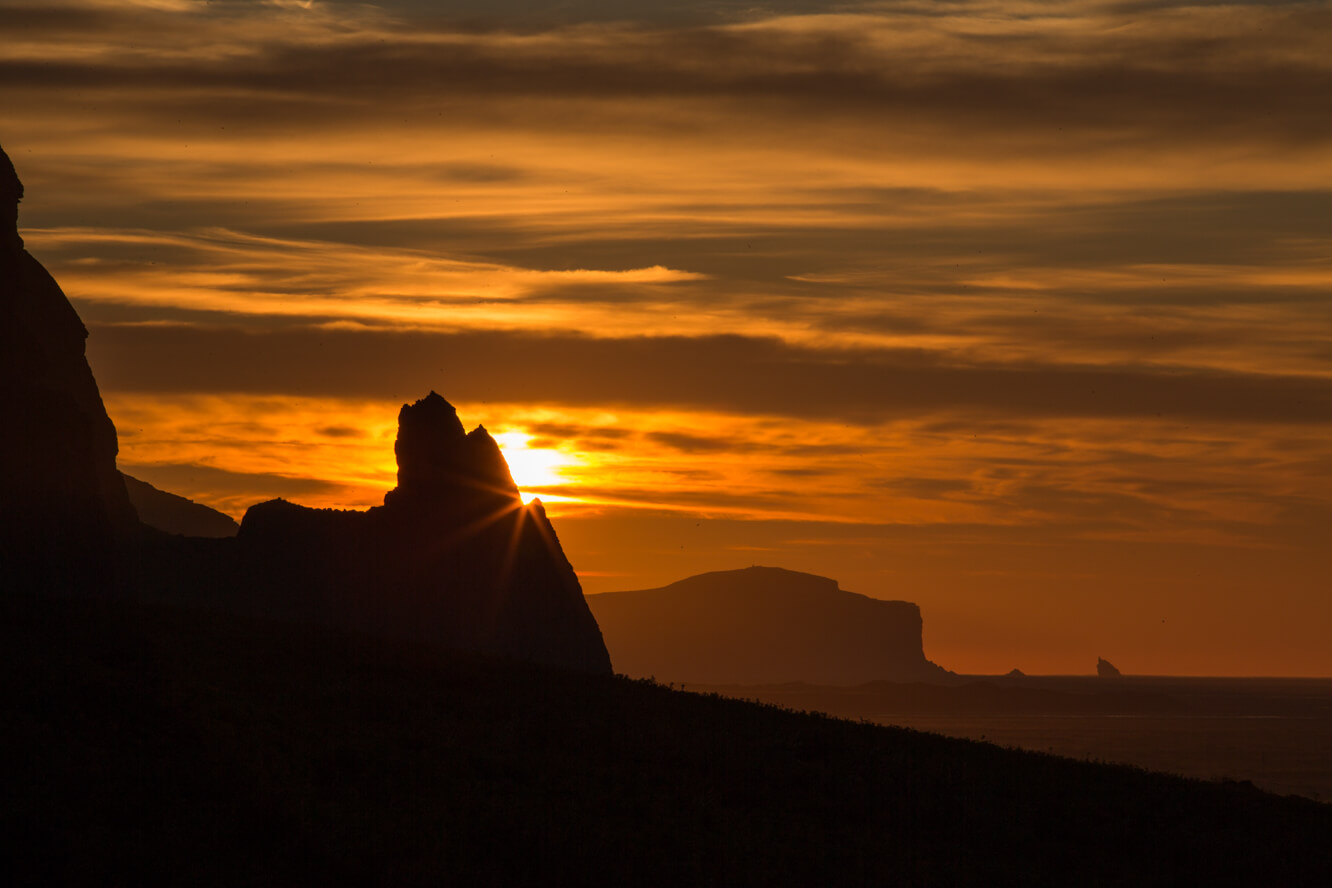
[0,0,1332,675]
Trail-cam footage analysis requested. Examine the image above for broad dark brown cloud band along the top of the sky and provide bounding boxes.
[0,4,1332,164]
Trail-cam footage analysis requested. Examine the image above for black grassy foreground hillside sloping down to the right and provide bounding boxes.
[0,596,1332,885]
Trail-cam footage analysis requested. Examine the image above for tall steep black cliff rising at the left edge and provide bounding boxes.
[0,142,139,592]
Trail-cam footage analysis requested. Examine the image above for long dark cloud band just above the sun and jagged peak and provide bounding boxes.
[89,326,1332,425]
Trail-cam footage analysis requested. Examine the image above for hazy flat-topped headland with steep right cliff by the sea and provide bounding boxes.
[587,567,950,684]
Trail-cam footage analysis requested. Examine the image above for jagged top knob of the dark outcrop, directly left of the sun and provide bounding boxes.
[384,391,519,505]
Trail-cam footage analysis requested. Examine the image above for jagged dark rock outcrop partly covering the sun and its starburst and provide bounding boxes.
[237,391,610,674]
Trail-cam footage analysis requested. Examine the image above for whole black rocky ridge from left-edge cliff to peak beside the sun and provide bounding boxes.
[0,144,611,674]
